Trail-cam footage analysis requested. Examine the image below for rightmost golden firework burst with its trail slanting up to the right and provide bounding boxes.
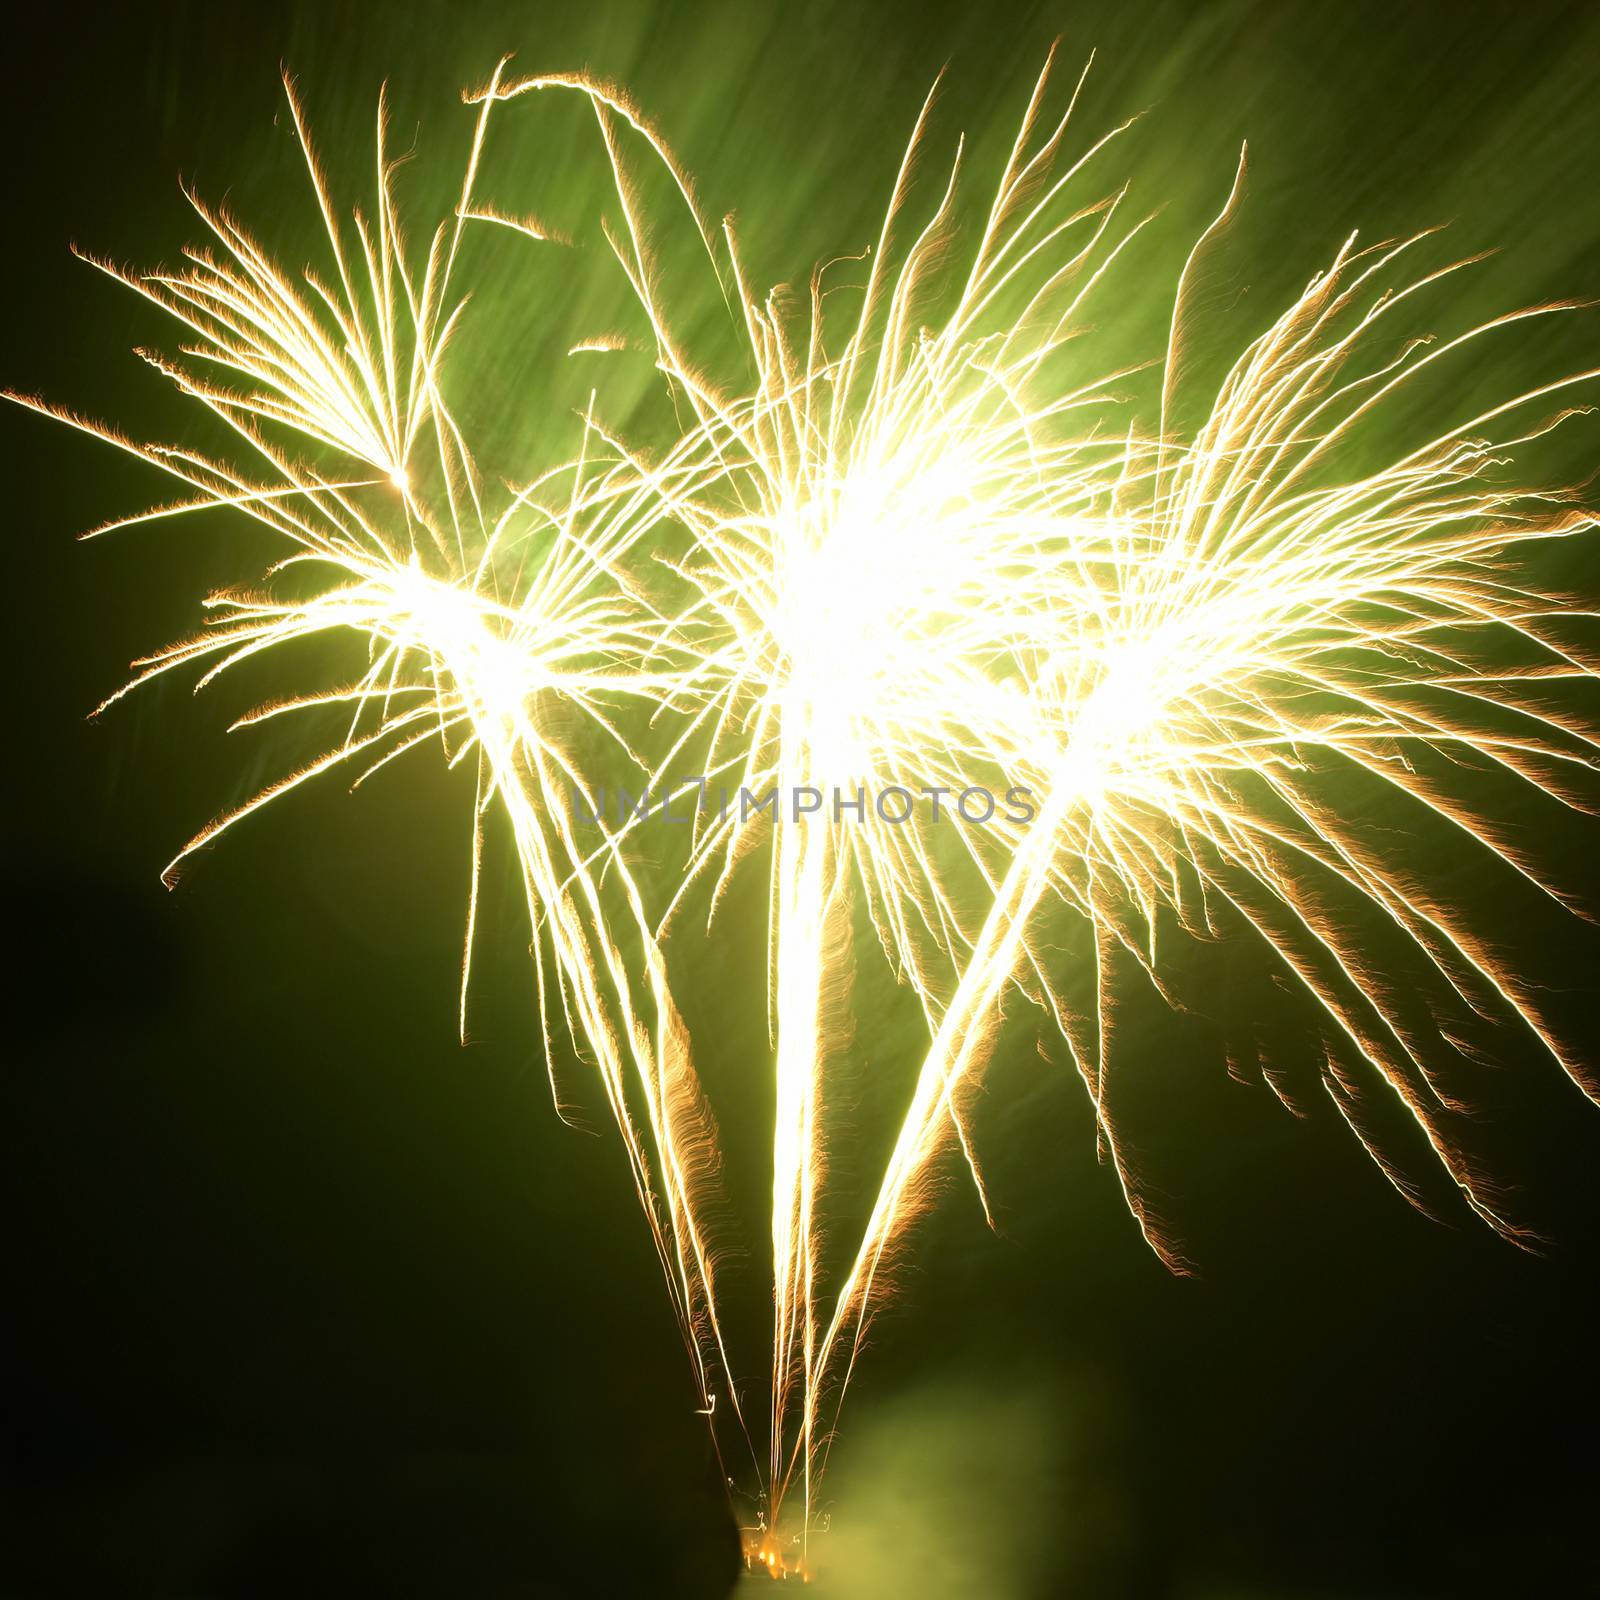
[816,175,1600,1484]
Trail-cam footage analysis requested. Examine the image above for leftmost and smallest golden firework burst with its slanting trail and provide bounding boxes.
[11,80,755,1484]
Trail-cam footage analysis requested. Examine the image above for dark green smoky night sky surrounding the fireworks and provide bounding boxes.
[9,3,1600,1600]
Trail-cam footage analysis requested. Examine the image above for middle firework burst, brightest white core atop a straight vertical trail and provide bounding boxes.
[483,53,1139,1558]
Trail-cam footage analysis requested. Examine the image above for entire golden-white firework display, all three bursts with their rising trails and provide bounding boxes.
[15,46,1600,1573]
